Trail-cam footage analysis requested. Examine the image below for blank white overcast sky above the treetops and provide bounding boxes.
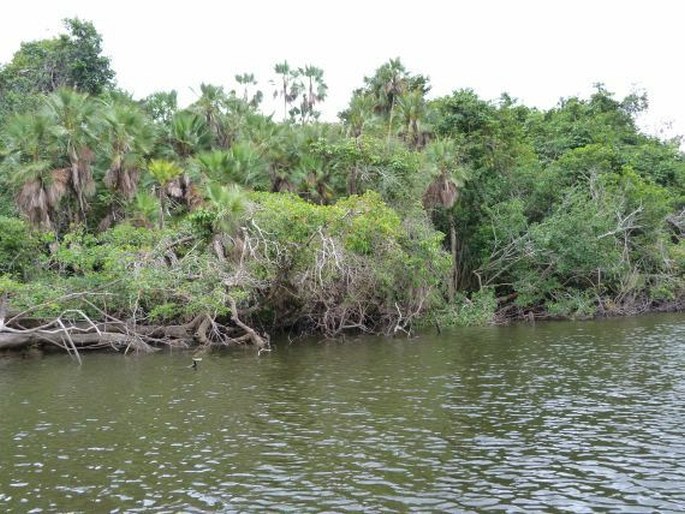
[0,0,685,137]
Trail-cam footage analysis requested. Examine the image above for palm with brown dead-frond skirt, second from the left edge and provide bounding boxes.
[46,88,96,221]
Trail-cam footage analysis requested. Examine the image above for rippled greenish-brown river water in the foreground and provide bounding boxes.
[0,315,685,513]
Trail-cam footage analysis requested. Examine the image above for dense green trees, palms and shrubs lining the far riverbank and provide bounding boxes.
[0,20,685,347]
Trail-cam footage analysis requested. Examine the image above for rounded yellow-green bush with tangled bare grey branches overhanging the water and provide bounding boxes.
[250,192,449,329]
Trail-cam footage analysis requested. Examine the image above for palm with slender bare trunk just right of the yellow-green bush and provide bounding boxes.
[423,139,468,300]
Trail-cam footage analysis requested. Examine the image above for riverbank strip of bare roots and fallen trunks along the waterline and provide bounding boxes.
[0,288,685,356]
